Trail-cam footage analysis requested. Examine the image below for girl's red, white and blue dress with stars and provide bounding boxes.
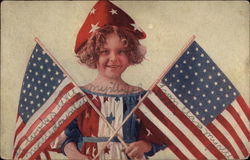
[61,88,166,159]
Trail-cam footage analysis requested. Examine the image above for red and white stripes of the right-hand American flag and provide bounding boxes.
[139,83,250,159]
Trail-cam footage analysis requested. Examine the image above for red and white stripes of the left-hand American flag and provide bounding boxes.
[13,78,89,159]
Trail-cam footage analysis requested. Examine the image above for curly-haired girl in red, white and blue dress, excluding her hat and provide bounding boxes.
[61,1,165,159]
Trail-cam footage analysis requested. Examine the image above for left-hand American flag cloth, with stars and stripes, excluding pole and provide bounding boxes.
[13,44,88,159]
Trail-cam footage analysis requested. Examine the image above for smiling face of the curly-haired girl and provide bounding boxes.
[97,33,129,79]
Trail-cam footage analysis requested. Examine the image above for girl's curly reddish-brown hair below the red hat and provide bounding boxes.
[76,25,146,68]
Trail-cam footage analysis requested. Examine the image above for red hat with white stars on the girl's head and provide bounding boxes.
[75,0,146,53]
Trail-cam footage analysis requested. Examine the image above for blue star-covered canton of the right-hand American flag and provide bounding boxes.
[162,42,239,125]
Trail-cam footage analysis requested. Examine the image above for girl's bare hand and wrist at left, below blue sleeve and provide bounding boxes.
[64,142,92,160]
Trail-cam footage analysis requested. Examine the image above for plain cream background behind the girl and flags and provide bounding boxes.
[1,1,249,159]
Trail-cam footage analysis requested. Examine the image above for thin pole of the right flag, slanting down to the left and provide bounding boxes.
[94,35,195,159]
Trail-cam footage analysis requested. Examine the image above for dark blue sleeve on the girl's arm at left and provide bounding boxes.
[61,119,81,155]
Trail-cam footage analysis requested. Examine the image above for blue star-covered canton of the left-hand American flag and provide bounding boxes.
[18,44,65,122]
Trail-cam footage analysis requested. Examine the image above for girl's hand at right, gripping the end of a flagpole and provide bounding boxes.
[125,140,152,159]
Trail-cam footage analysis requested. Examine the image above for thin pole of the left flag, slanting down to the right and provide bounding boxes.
[34,37,128,148]
